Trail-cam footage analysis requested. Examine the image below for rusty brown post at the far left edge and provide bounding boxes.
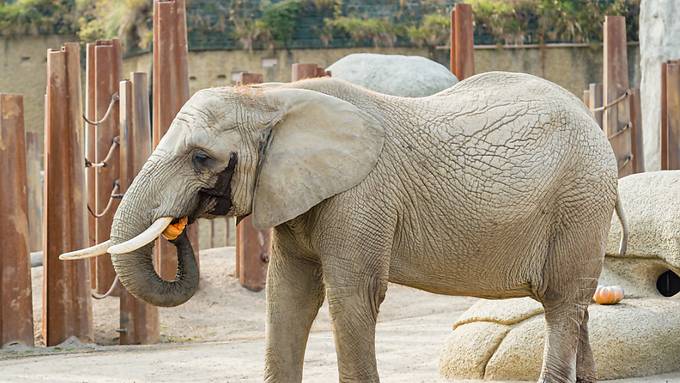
[0,93,33,348]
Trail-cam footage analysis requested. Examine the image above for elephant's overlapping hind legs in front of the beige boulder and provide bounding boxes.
[539,226,604,383]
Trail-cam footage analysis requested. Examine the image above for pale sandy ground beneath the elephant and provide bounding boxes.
[0,248,680,383]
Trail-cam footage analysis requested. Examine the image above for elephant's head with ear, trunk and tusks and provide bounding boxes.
[60,87,384,306]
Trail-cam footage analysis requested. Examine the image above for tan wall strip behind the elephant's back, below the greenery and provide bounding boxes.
[124,44,640,97]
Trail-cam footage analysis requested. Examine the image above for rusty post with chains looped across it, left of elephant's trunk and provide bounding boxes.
[89,39,123,296]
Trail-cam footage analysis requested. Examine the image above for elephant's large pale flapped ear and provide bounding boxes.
[252,89,384,228]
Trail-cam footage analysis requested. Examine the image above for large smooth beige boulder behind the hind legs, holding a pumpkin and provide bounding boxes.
[440,171,680,381]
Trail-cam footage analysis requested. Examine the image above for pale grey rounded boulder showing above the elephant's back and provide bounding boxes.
[326,53,458,97]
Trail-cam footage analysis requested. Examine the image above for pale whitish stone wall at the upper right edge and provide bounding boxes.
[640,0,680,171]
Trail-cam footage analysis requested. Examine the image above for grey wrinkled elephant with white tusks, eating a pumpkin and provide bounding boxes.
[64,72,625,382]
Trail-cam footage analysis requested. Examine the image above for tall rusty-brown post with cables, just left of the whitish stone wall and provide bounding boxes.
[603,16,633,177]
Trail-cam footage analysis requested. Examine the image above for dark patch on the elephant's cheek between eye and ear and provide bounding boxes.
[197,153,238,219]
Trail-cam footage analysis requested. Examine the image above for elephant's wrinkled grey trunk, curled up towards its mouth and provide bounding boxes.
[111,187,199,307]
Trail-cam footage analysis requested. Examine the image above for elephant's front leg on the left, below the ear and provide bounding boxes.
[264,238,324,383]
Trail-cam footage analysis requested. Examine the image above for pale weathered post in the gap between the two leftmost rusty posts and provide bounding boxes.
[26,132,43,251]
